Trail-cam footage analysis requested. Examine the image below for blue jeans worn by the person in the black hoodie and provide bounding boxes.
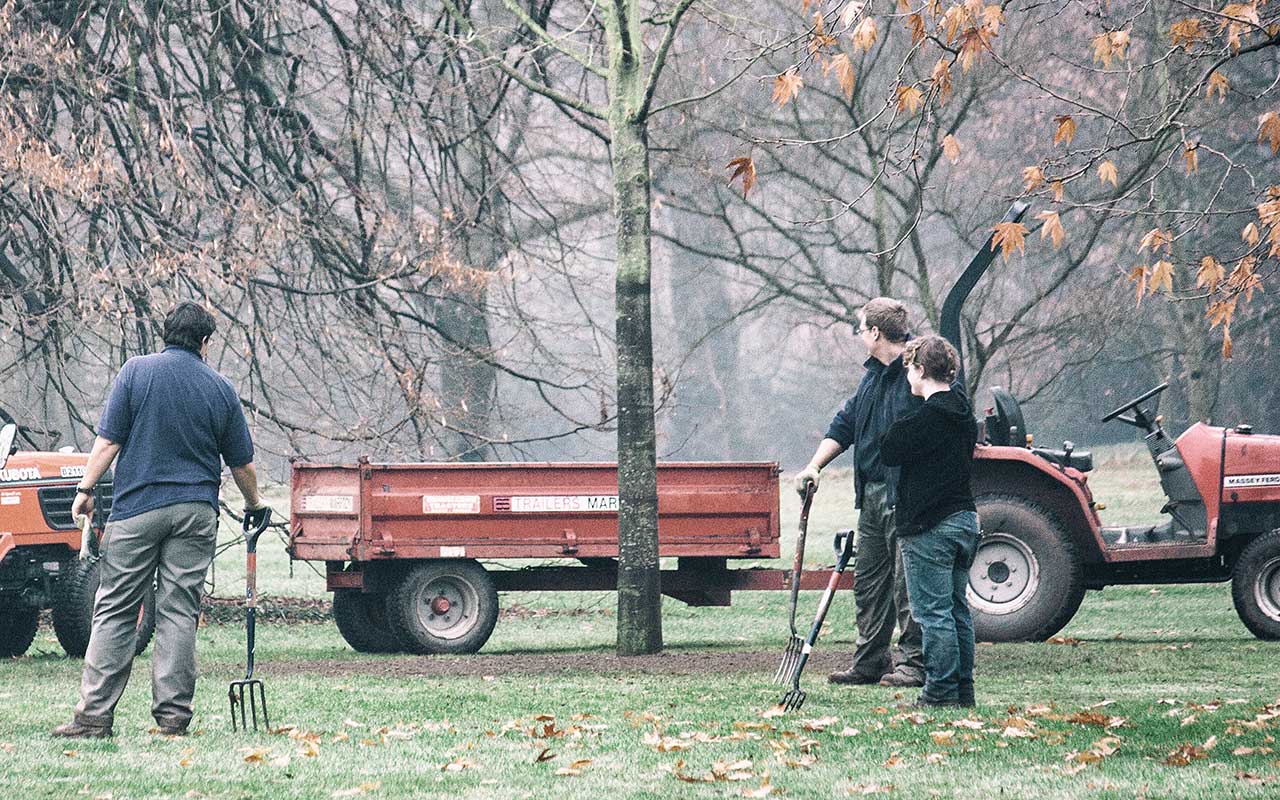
[899,511,978,701]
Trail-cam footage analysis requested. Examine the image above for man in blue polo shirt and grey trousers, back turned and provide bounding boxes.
[54,302,270,737]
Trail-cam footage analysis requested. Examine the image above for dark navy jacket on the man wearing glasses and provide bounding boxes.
[827,356,923,508]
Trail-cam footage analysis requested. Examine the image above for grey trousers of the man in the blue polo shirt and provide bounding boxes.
[76,503,218,727]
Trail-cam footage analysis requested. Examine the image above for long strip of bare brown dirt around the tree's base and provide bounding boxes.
[260,650,850,681]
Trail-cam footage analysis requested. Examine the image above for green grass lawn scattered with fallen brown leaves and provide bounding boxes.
[0,453,1280,799]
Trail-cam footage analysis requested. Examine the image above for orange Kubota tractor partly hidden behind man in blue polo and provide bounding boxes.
[0,411,155,658]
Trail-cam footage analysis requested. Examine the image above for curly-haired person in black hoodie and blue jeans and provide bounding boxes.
[879,335,979,707]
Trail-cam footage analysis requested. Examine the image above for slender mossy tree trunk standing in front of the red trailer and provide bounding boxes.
[605,1,662,655]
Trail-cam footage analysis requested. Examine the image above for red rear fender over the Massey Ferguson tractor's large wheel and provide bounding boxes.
[973,445,1105,563]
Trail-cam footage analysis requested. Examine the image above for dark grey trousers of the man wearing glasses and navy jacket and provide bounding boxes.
[850,483,924,680]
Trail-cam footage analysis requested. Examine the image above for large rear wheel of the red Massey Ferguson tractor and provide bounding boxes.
[968,494,1085,641]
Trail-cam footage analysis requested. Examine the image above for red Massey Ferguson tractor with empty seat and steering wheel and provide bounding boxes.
[941,204,1280,641]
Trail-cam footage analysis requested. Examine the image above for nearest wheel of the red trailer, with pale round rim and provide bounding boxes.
[387,561,498,655]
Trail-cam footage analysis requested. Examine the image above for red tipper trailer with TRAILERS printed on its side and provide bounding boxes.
[289,458,852,653]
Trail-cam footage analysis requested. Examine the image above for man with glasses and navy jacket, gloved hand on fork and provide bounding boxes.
[795,297,924,686]
